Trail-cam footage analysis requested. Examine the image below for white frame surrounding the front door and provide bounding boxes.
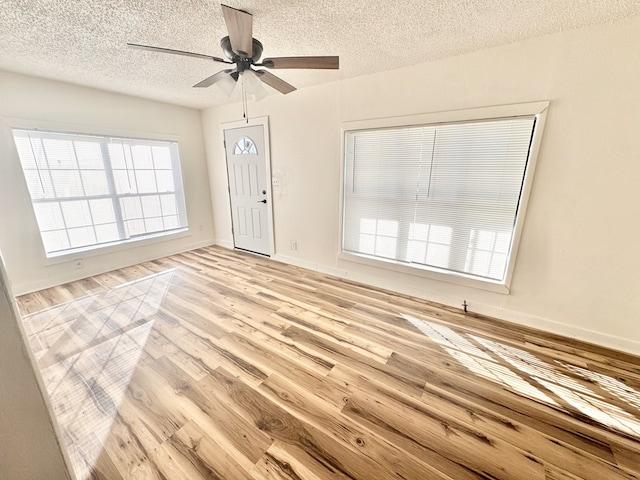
[220,116,276,257]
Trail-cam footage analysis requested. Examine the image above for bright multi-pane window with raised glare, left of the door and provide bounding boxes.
[13,129,187,257]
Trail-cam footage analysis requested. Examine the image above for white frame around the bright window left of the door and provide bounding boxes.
[5,118,193,266]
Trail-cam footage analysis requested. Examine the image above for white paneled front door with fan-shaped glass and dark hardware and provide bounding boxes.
[224,125,271,255]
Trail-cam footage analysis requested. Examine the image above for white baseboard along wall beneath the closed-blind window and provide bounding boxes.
[272,254,640,355]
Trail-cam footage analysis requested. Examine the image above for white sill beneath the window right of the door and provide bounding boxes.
[338,252,509,295]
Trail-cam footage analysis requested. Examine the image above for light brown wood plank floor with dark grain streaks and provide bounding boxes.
[19,247,640,480]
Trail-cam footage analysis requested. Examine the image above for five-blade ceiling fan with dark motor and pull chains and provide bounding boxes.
[127,5,340,100]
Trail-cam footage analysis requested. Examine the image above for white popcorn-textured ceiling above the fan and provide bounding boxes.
[0,0,640,108]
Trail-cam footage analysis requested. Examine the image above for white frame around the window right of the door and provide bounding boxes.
[338,101,549,294]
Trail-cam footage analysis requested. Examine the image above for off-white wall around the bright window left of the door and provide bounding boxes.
[0,71,214,294]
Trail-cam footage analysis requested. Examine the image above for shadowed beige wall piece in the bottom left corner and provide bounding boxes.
[0,251,70,480]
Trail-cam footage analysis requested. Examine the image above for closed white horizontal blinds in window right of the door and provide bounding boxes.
[342,115,536,282]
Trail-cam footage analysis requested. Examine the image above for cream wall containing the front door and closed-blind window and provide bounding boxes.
[203,17,640,353]
